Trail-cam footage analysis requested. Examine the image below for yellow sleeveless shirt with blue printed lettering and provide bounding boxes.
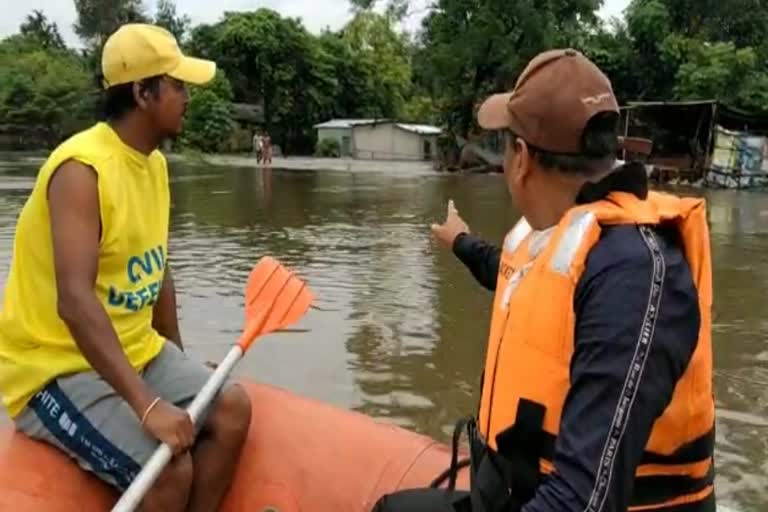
[0,123,170,417]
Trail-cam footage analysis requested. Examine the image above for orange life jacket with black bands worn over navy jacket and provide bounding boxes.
[477,192,715,510]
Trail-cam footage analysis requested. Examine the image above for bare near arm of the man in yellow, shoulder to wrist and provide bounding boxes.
[48,161,154,416]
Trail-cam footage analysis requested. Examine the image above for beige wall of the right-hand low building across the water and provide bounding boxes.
[352,123,437,160]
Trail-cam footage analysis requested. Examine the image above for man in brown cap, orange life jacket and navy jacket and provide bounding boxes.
[375,50,715,512]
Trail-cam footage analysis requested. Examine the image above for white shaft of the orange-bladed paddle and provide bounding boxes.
[112,345,243,512]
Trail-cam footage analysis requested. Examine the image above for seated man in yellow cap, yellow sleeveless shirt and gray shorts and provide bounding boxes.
[0,24,251,512]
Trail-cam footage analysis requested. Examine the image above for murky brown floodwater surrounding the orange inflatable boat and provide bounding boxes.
[0,158,768,512]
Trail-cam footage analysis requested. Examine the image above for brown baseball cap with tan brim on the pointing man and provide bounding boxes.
[477,48,619,154]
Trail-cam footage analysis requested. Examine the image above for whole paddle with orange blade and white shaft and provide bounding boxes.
[112,256,314,512]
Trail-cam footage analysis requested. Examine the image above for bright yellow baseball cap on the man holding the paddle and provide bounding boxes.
[101,23,216,89]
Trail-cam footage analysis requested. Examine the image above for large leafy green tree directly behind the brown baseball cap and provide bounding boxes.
[414,0,600,134]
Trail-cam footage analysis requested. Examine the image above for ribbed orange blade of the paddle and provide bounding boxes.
[238,256,315,351]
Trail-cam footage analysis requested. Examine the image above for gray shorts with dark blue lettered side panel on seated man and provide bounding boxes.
[15,342,226,490]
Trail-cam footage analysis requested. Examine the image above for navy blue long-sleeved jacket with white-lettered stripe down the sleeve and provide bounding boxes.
[453,217,700,512]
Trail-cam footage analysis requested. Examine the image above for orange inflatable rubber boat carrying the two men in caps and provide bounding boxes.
[0,382,468,512]
